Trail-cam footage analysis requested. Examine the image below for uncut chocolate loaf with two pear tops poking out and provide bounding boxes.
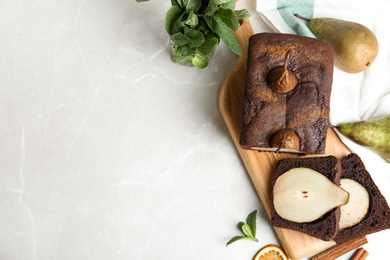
[240,33,333,154]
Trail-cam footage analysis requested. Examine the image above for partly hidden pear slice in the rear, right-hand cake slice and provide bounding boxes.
[339,179,370,229]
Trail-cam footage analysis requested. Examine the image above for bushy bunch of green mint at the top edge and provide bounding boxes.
[136,0,250,69]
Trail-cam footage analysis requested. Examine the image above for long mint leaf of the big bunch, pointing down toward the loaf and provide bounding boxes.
[204,15,242,55]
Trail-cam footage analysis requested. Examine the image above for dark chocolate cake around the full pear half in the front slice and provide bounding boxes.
[271,156,341,241]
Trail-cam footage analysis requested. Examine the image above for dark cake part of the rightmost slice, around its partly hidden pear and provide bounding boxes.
[334,154,390,244]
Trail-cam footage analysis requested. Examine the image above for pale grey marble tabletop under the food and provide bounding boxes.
[0,0,390,260]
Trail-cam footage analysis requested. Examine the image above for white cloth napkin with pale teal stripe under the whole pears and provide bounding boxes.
[256,0,390,176]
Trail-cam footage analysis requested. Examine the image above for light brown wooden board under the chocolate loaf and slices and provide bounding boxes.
[219,19,350,260]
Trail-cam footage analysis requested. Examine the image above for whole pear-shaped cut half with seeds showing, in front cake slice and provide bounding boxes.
[273,167,349,223]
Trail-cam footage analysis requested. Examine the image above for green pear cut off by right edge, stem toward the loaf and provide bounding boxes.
[337,115,390,162]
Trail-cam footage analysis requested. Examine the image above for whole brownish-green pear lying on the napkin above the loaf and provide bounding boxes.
[296,15,379,73]
